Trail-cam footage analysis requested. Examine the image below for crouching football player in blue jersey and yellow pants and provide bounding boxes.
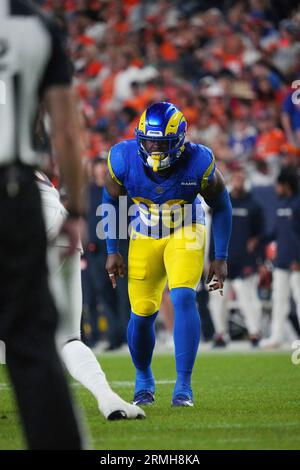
[102,102,231,406]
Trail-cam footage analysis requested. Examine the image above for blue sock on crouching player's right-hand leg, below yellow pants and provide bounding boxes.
[171,287,200,396]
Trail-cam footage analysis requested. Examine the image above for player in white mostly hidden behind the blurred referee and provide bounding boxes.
[36,172,145,420]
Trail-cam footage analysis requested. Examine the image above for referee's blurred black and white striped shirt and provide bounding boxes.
[0,0,71,167]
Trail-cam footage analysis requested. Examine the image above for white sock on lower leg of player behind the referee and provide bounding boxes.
[61,340,111,403]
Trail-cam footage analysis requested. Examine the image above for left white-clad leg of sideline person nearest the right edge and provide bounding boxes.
[260,268,290,348]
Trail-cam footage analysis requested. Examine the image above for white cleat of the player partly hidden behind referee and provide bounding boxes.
[98,390,146,421]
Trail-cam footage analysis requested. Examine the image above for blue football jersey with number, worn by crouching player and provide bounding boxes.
[108,139,216,238]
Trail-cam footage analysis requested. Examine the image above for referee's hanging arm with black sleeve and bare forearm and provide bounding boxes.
[40,23,83,255]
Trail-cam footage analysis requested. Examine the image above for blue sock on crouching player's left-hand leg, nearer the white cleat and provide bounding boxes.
[127,312,158,393]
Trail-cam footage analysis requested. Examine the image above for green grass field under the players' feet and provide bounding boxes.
[0,353,300,450]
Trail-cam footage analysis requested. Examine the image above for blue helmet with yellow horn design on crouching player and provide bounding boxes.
[135,102,187,172]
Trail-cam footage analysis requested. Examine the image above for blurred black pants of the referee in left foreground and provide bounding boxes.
[0,166,81,449]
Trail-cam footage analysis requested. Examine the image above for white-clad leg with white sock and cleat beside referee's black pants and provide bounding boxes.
[49,247,144,419]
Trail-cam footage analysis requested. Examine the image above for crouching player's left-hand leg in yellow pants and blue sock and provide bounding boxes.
[127,236,166,404]
